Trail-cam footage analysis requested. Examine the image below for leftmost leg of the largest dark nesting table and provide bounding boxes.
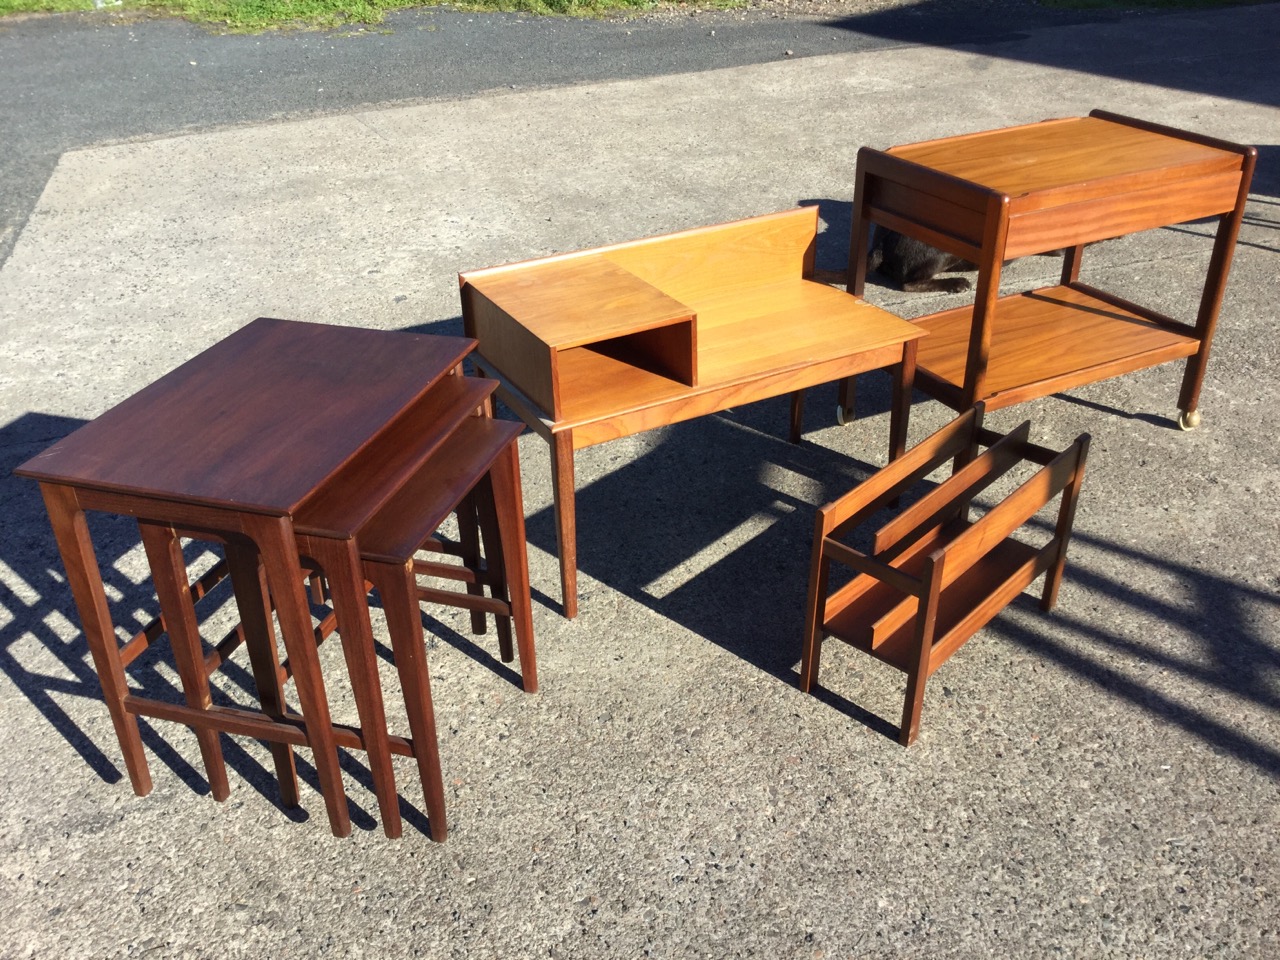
[40,484,151,796]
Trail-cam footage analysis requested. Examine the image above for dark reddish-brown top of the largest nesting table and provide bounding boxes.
[18,317,475,515]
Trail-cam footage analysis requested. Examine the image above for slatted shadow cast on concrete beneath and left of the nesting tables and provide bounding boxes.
[0,413,445,835]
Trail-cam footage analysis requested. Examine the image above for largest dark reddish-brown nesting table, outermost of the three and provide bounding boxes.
[14,319,491,836]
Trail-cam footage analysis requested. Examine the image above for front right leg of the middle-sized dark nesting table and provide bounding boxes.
[298,536,401,838]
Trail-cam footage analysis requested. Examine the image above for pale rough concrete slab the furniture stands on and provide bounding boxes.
[0,5,1280,960]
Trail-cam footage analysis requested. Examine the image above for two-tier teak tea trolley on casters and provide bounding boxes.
[849,110,1257,430]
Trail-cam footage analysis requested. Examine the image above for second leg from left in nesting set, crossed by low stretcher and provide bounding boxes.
[138,520,230,800]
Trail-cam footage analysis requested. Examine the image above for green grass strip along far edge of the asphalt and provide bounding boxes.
[0,0,675,32]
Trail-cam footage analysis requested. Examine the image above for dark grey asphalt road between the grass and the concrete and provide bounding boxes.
[0,0,1098,266]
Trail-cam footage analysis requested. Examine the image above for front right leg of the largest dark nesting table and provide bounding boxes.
[243,515,351,837]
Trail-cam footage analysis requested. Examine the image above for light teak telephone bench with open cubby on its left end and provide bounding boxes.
[458,207,923,617]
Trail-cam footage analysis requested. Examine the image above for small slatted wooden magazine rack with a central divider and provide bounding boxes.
[800,403,1089,746]
